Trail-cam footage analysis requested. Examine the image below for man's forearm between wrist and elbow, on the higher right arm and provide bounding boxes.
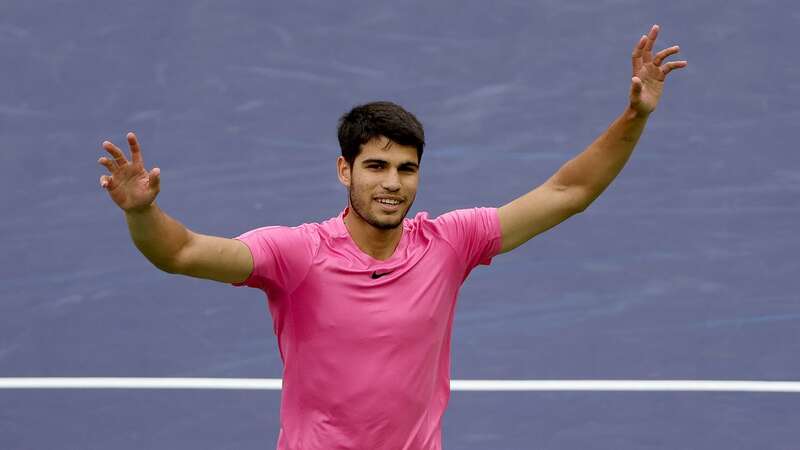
[552,108,648,208]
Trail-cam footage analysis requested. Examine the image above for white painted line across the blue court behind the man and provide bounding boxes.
[0,378,800,393]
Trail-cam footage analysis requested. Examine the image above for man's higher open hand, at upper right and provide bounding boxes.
[630,25,689,116]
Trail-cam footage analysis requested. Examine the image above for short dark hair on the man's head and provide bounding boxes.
[338,101,425,167]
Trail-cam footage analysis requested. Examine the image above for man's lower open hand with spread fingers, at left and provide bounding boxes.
[97,133,161,212]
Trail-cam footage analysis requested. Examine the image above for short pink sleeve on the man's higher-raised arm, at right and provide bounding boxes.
[435,208,502,272]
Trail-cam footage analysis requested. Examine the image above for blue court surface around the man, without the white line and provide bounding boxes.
[0,0,800,450]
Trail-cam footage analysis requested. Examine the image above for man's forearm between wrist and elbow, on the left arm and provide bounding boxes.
[125,202,189,272]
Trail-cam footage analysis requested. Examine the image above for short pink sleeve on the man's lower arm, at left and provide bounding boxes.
[231,224,319,293]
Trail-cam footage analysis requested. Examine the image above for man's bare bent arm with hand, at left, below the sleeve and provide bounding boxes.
[98,133,253,283]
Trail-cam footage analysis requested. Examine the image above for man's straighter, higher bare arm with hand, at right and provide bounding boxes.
[498,25,688,253]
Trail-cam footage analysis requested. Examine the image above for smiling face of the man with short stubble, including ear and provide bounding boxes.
[337,136,419,230]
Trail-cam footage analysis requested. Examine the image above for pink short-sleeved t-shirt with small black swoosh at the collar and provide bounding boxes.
[234,208,501,450]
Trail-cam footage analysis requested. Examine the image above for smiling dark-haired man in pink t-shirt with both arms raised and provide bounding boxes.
[99,25,687,450]
